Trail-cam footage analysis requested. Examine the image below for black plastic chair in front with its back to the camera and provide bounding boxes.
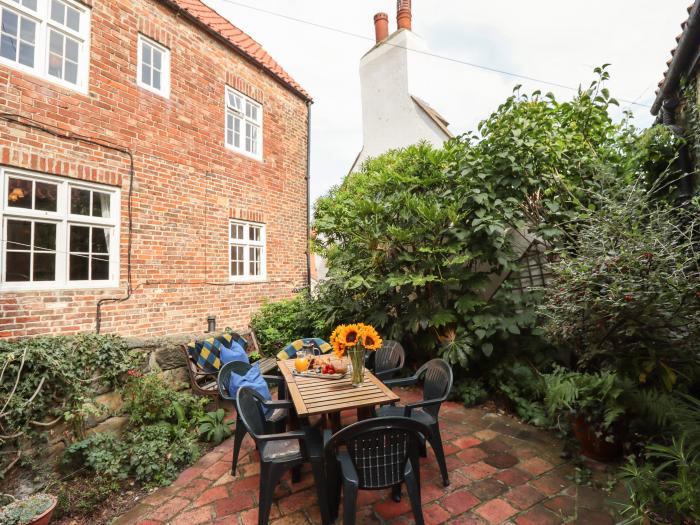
[324,417,430,525]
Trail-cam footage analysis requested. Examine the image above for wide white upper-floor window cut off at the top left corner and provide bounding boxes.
[0,0,90,93]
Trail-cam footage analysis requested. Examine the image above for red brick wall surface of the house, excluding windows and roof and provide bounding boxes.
[0,0,307,337]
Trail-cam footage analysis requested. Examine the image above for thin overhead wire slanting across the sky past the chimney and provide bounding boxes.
[219,0,651,108]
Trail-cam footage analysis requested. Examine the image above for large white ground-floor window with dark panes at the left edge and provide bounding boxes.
[0,167,120,291]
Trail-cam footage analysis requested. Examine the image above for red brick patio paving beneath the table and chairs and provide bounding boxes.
[113,389,615,525]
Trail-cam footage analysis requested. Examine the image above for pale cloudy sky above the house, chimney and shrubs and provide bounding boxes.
[204,0,691,205]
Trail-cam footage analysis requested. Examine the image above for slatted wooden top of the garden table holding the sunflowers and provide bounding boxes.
[279,359,399,419]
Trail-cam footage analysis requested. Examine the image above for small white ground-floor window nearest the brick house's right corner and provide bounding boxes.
[229,220,267,281]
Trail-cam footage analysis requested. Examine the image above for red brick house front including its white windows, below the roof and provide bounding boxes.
[0,0,311,337]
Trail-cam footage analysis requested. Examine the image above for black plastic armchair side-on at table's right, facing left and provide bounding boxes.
[377,359,453,487]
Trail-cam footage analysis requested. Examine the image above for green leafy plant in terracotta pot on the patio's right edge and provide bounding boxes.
[543,367,627,461]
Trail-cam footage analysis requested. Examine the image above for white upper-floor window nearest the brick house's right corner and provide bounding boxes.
[225,86,263,160]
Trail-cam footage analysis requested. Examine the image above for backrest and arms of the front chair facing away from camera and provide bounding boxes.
[325,417,430,489]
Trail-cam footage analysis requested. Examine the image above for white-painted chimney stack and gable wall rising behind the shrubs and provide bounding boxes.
[353,29,448,169]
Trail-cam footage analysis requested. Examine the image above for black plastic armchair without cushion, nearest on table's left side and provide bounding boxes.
[236,387,330,525]
